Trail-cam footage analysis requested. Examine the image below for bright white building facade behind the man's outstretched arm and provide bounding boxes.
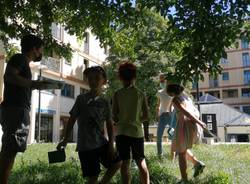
[0,24,107,144]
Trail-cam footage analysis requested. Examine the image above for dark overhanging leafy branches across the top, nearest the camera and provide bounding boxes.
[0,0,250,80]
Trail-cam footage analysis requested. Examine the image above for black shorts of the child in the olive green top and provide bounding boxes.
[116,135,145,160]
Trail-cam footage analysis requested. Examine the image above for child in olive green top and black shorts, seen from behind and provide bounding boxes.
[113,62,149,184]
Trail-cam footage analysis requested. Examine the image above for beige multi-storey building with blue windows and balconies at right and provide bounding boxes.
[192,39,250,114]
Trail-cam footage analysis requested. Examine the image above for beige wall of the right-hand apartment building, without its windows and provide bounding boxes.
[192,41,250,113]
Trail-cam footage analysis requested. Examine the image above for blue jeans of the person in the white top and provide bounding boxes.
[157,113,172,155]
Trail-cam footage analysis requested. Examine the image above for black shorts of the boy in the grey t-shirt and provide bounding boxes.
[78,144,121,177]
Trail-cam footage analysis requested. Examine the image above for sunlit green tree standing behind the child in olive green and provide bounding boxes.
[105,9,182,122]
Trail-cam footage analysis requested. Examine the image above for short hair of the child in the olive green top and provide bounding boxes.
[119,61,136,81]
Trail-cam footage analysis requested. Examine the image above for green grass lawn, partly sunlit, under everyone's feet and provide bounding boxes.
[10,144,250,184]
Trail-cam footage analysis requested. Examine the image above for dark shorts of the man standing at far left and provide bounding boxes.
[0,106,30,152]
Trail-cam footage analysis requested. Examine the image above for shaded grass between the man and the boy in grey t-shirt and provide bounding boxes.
[10,159,84,184]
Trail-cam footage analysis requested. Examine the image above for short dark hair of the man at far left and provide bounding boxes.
[21,34,43,53]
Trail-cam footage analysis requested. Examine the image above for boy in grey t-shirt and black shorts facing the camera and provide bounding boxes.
[57,66,120,184]
